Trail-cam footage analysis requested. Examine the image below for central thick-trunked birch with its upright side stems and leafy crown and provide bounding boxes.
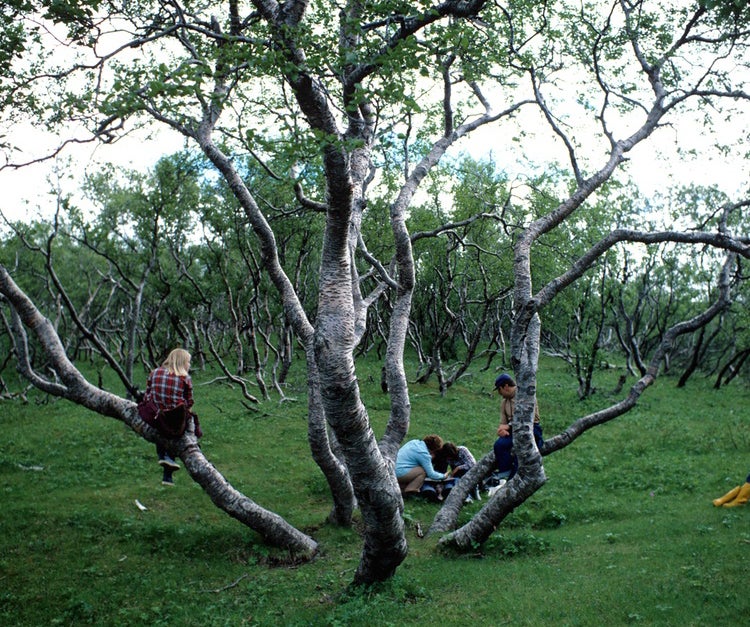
[2,0,508,583]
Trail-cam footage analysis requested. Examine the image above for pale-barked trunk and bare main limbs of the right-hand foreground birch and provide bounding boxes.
[434,3,748,549]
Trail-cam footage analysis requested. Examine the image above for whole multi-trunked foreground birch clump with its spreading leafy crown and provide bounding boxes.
[0,0,748,583]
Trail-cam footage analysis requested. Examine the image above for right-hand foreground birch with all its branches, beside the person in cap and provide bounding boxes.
[433,2,750,548]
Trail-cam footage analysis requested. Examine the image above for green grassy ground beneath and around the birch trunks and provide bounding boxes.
[0,362,750,626]
